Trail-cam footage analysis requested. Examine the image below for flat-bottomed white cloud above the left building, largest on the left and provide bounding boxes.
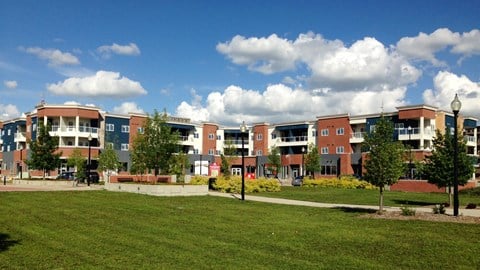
[47,70,147,97]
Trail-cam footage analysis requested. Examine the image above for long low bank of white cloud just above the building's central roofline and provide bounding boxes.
[175,84,406,125]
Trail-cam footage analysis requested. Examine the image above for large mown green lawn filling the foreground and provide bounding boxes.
[0,191,480,269]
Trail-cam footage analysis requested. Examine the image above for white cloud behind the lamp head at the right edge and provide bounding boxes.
[423,71,480,118]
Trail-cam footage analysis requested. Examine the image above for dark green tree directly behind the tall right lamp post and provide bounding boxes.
[422,130,475,202]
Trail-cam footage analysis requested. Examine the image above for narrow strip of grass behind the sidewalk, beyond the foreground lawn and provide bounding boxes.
[252,187,480,207]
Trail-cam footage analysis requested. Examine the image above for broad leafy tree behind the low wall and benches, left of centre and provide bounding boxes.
[132,111,179,175]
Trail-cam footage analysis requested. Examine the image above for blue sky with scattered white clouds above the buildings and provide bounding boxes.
[0,0,480,126]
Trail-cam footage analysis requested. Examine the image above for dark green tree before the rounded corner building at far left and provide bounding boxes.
[26,123,62,180]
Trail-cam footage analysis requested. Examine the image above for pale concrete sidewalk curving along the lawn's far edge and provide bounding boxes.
[208,191,480,217]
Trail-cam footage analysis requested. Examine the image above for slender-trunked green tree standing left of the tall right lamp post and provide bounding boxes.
[364,115,405,213]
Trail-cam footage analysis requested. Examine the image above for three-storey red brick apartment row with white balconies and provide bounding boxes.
[0,103,480,178]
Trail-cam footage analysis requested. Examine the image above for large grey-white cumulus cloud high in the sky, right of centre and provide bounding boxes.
[217,32,422,91]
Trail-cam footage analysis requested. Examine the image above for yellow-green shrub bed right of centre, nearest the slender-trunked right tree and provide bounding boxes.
[303,176,376,189]
